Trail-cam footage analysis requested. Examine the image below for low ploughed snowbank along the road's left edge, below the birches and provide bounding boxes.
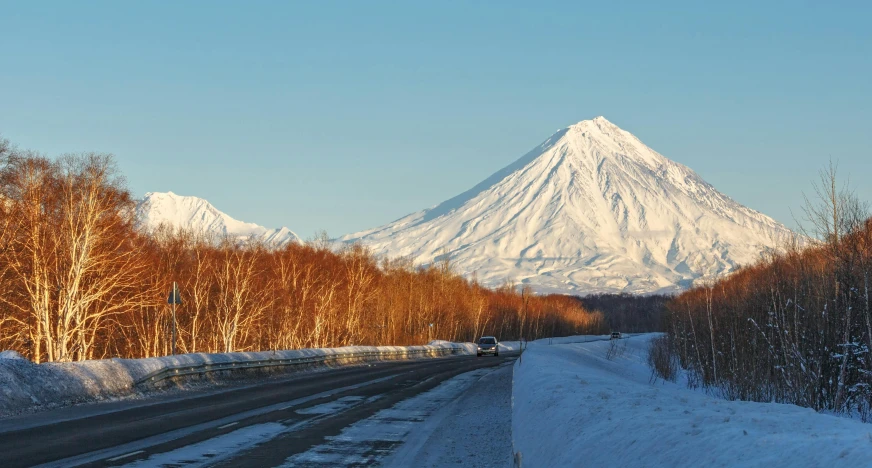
[0,342,475,417]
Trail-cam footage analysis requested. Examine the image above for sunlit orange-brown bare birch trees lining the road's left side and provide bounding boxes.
[0,141,607,362]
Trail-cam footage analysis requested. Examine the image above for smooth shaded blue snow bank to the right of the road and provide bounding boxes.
[512,335,872,467]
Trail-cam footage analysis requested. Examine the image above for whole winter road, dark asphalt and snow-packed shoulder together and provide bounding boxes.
[0,352,515,467]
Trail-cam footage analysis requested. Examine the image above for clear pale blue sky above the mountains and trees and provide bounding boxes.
[0,0,872,237]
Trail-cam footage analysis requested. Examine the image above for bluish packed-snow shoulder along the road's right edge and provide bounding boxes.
[283,366,512,468]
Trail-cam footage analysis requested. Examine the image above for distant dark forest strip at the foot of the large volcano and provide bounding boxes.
[578,293,672,333]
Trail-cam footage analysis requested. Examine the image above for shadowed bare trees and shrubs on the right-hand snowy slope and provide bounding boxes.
[652,167,872,419]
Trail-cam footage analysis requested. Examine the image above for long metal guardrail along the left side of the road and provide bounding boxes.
[134,347,466,386]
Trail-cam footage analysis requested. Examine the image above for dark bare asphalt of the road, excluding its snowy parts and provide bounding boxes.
[0,352,517,468]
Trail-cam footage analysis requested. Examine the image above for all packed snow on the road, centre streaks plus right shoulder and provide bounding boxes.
[110,364,512,468]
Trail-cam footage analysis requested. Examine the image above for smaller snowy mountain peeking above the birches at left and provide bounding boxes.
[136,192,302,246]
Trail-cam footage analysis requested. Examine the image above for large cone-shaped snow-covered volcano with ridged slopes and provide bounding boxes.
[341,117,790,293]
